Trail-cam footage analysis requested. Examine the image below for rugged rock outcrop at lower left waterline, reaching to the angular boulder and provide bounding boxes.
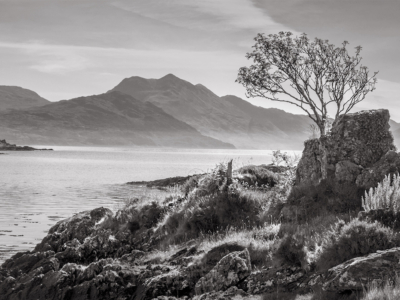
[0,208,255,300]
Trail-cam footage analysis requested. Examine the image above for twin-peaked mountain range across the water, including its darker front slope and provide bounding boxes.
[0,74,400,150]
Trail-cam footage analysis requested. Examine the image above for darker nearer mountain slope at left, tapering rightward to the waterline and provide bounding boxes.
[0,92,234,148]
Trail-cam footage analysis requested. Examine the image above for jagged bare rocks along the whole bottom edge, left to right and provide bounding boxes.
[0,208,400,300]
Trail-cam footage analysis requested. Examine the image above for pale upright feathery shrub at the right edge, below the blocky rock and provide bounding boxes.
[362,174,400,213]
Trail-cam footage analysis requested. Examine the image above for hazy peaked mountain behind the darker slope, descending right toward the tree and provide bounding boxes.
[111,74,311,149]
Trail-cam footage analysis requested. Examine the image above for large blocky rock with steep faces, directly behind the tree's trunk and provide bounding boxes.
[296,109,400,188]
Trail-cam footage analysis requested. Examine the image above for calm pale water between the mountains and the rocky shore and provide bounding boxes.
[0,146,284,263]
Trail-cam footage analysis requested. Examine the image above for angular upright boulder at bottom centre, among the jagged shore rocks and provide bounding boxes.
[195,249,251,295]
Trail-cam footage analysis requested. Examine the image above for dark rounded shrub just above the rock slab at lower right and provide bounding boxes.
[316,219,399,270]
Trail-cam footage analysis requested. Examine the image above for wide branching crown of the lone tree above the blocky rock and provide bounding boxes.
[236,32,378,137]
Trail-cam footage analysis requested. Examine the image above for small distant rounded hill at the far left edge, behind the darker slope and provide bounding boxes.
[0,85,50,111]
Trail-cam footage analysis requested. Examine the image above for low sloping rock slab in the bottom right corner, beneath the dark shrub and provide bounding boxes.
[323,248,400,293]
